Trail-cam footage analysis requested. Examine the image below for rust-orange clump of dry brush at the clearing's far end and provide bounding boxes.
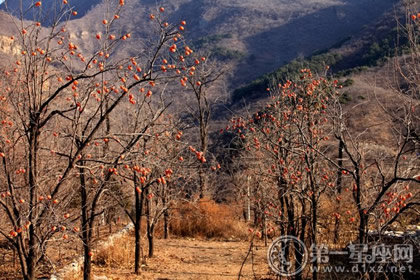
[170,199,247,239]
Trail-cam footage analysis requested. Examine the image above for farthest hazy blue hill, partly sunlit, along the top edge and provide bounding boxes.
[0,0,398,88]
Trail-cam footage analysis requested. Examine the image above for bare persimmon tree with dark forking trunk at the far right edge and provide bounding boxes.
[331,3,420,243]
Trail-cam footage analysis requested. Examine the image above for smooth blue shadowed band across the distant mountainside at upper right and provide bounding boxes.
[235,1,395,83]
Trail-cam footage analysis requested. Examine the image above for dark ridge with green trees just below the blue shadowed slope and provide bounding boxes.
[232,1,407,105]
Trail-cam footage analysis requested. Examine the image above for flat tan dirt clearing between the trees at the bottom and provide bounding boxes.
[94,239,275,280]
